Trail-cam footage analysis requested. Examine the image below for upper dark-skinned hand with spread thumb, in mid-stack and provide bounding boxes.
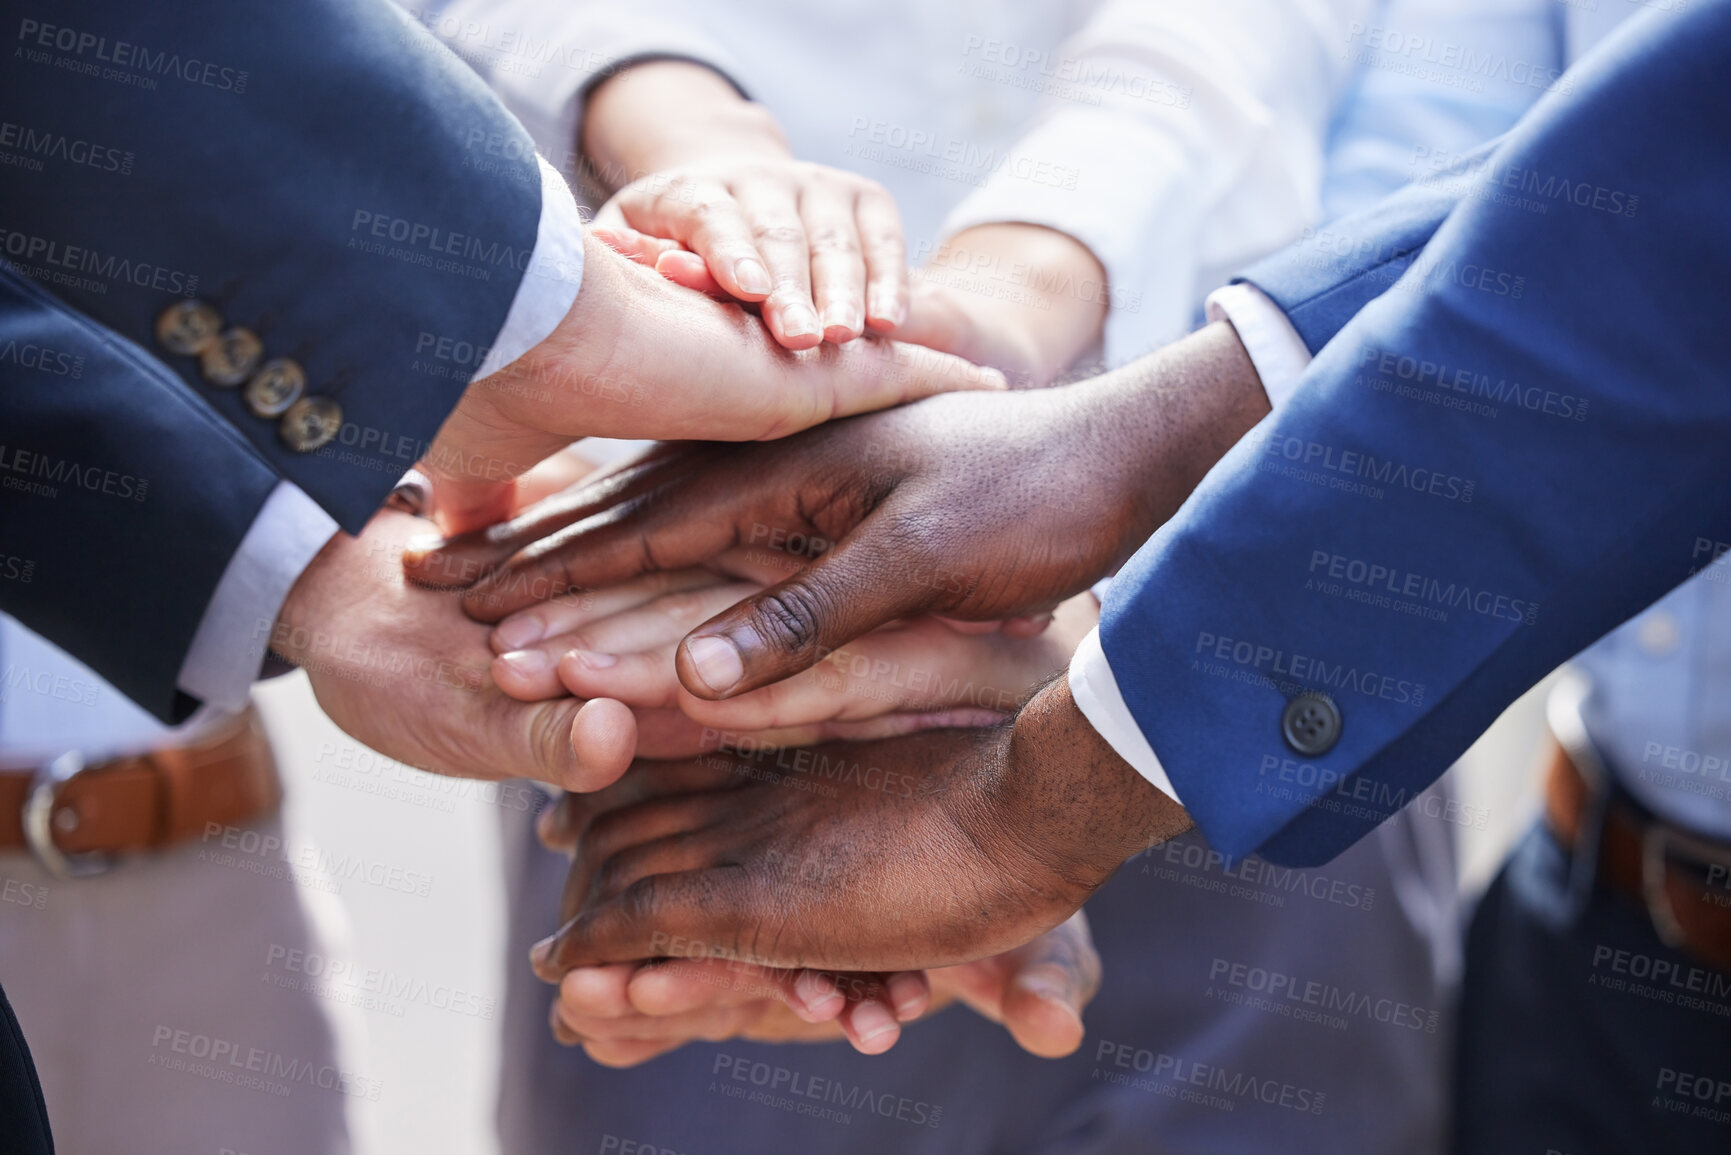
[405,322,1267,700]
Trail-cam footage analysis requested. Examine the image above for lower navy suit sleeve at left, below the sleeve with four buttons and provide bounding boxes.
[0,265,279,722]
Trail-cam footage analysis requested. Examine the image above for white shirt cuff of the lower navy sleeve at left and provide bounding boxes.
[177,481,338,710]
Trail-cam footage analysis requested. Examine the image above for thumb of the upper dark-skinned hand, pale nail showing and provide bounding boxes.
[675,529,940,701]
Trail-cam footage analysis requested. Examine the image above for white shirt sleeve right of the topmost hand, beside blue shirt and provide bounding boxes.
[945,0,1376,365]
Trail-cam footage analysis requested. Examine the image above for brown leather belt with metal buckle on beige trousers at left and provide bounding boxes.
[0,707,282,874]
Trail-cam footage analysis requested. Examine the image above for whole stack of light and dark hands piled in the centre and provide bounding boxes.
[273,69,1265,1065]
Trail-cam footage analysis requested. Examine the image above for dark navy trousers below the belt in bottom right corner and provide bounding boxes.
[1454,826,1731,1155]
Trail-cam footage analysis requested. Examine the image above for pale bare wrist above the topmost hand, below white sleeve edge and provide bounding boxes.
[576,61,791,196]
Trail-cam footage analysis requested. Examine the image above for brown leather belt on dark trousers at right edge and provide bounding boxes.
[1544,743,1731,970]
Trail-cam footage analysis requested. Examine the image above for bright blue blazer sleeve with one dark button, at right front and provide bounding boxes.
[1101,0,1731,864]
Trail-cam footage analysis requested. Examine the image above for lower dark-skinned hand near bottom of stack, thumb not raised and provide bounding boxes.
[531,681,1189,982]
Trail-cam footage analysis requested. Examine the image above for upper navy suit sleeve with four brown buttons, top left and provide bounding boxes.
[0,0,540,532]
